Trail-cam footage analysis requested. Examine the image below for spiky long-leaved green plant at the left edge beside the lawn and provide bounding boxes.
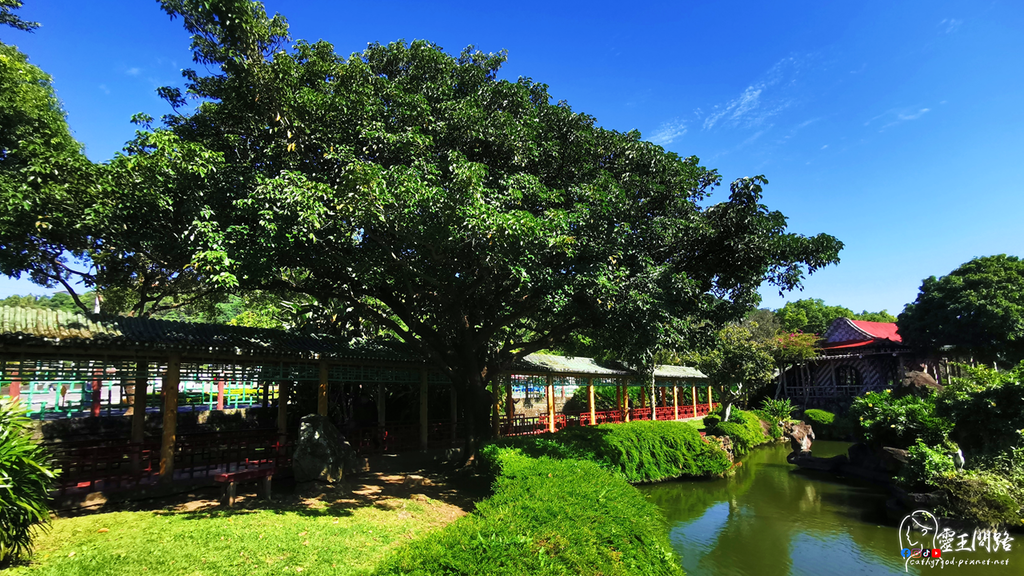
[0,400,53,566]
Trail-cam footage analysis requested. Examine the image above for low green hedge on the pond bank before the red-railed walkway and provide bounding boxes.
[485,420,729,483]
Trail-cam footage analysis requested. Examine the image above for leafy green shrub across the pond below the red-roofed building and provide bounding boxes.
[850,390,952,448]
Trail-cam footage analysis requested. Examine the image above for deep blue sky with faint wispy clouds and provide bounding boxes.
[0,0,1024,314]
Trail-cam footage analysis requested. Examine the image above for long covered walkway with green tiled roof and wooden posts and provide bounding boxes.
[0,307,714,492]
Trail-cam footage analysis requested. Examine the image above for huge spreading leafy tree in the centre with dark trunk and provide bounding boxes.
[96,0,842,448]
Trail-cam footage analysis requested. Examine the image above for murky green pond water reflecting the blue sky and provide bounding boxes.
[639,442,1024,576]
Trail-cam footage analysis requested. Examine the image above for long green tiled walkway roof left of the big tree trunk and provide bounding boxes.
[0,306,414,361]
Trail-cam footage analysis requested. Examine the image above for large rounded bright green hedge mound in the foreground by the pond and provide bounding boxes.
[377,445,683,576]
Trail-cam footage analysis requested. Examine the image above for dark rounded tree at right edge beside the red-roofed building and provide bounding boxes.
[898,254,1024,366]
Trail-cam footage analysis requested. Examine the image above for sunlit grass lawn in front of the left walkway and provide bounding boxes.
[6,473,465,576]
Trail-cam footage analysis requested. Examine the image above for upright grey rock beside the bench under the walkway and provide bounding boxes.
[292,414,355,483]
